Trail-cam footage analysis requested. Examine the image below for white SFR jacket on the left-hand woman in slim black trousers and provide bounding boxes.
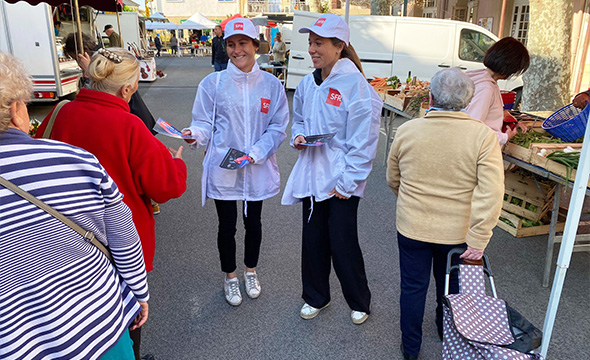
[187,61,289,206]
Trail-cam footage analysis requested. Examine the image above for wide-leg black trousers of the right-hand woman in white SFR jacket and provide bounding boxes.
[301,196,371,313]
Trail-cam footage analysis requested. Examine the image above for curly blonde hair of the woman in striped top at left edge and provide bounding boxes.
[0,52,33,134]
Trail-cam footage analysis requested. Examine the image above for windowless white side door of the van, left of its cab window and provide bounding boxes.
[393,17,455,80]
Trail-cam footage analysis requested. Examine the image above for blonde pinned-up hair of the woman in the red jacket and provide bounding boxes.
[88,48,139,95]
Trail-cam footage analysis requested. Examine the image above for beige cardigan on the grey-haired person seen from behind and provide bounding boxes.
[387,111,504,250]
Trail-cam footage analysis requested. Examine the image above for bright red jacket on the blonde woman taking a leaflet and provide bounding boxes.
[37,89,186,271]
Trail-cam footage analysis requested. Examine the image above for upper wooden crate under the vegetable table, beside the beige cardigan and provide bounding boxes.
[502,171,555,221]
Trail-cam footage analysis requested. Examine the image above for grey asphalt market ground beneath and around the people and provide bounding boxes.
[31,57,590,360]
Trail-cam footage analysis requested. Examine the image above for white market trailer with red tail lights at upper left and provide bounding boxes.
[0,0,81,101]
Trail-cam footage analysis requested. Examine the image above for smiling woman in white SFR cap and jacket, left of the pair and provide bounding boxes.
[183,18,289,306]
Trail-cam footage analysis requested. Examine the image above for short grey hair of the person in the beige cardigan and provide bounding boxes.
[430,68,475,111]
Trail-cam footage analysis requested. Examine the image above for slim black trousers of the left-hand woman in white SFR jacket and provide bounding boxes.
[215,200,262,273]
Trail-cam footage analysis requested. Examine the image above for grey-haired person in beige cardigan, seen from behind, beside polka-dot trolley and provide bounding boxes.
[387,68,504,360]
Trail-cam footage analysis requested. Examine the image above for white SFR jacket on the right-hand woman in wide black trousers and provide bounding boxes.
[282,58,383,205]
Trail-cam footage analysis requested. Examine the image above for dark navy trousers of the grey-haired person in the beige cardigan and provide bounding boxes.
[397,232,467,355]
